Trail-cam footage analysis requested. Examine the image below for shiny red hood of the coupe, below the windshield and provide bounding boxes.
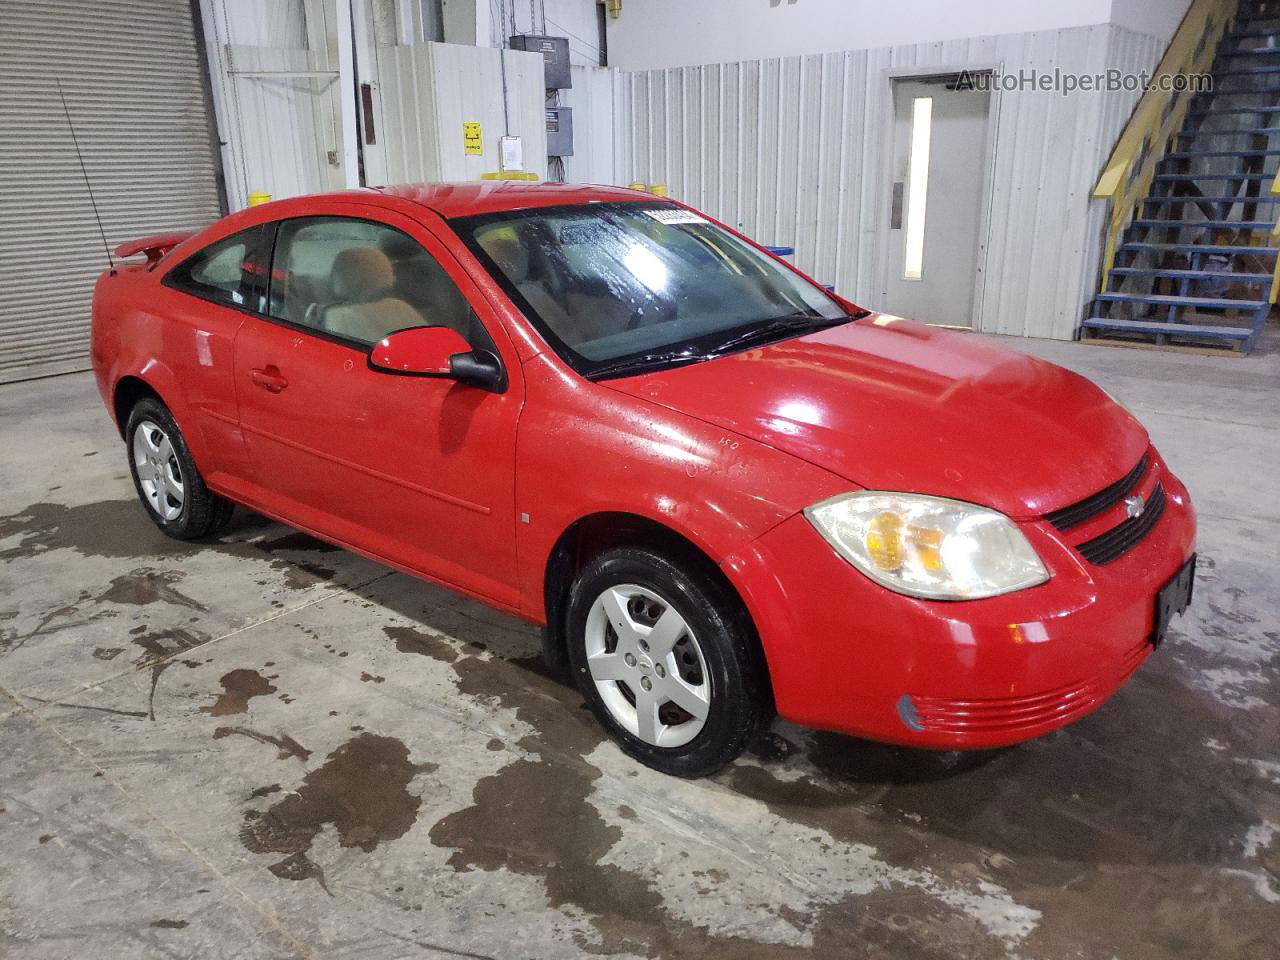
[600,314,1149,517]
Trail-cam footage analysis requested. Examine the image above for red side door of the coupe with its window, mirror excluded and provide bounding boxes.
[236,204,524,608]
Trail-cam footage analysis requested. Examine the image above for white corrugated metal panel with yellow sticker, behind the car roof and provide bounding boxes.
[366,44,547,186]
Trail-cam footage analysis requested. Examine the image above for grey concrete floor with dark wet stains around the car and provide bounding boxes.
[0,340,1280,960]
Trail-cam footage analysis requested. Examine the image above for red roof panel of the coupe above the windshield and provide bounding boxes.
[372,180,650,219]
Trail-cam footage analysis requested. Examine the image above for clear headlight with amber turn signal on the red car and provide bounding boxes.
[804,492,1048,600]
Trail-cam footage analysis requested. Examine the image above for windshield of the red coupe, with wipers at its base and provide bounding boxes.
[453,204,849,378]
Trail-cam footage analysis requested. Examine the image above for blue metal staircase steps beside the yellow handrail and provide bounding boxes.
[1082,0,1280,353]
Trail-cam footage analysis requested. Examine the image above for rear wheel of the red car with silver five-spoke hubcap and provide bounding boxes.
[124,397,233,540]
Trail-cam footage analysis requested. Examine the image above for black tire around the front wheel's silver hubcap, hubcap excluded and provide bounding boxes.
[566,547,771,777]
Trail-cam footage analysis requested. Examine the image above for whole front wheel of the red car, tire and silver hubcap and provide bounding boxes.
[567,548,767,777]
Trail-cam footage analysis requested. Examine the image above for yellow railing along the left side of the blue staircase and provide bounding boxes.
[1093,0,1239,289]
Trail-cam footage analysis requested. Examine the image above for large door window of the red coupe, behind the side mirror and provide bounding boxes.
[269,216,492,348]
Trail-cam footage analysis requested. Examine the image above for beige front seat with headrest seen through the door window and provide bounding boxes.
[320,247,426,343]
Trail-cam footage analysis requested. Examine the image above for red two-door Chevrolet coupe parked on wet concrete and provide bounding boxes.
[92,184,1196,777]
